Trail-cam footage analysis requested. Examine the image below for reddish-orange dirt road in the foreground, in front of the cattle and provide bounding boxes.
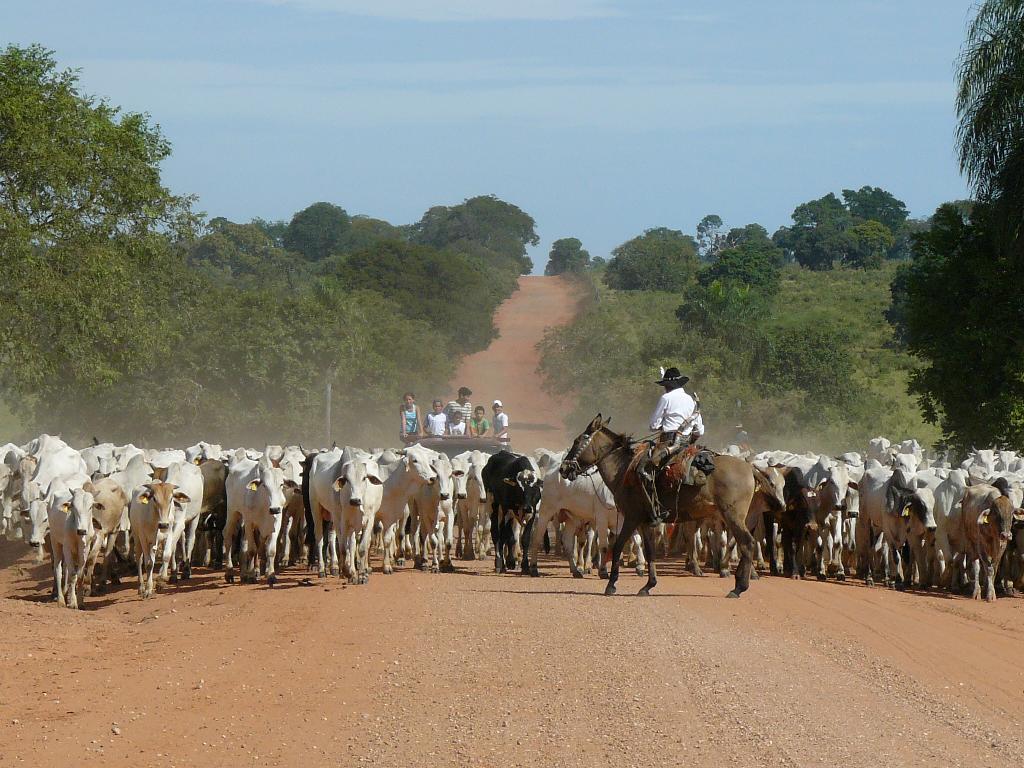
[0,544,1024,768]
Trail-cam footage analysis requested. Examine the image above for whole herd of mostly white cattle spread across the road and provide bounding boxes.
[0,434,1024,607]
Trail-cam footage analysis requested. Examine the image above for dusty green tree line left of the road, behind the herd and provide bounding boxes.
[0,45,537,443]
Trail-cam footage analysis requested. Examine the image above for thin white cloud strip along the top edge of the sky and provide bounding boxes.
[234,0,621,22]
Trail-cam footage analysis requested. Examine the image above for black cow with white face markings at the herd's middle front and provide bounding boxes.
[481,451,544,575]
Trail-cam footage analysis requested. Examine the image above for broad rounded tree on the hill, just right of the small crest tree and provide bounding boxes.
[604,227,697,291]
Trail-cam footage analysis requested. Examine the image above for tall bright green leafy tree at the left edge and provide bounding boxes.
[0,45,197,429]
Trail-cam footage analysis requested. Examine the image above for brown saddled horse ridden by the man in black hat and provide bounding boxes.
[559,414,758,597]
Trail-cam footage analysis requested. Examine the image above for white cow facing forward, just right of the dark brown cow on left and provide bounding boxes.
[224,454,301,587]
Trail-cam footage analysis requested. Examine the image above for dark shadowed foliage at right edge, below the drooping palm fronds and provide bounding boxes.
[889,204,1024,449]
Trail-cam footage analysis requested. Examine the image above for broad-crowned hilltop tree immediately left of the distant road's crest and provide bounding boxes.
[412,195,540,274]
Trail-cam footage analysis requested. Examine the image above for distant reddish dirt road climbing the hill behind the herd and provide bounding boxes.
[450,276,580,451]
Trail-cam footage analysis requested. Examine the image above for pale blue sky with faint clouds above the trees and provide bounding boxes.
[0,0,973,268]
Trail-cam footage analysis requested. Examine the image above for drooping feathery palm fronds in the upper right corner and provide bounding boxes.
[956,0,1024,211]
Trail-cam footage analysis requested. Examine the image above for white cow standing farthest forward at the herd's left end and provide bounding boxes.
[48,486,95,608]
